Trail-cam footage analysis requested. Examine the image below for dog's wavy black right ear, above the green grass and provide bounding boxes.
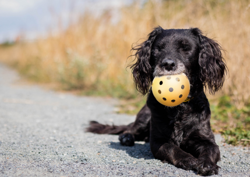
[192,28,227,94]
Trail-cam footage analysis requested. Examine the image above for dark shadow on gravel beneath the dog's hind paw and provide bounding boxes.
[110,142,154,159]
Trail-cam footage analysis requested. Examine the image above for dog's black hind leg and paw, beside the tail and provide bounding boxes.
[119,105,151,146]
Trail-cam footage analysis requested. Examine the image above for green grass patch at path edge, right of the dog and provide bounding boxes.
[211,96,250,146]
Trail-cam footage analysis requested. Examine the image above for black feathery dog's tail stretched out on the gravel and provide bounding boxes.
[85,121,132,135]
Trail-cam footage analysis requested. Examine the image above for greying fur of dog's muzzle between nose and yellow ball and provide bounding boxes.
[153,63,186,77]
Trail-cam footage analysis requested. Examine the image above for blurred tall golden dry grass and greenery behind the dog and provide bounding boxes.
[0,0,250,145]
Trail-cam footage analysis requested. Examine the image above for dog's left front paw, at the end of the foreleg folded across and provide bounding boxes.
[175,156,198,170]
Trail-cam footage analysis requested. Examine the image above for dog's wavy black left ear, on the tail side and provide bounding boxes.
[130,26,163,95]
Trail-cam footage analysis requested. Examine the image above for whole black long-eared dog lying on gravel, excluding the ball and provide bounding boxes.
[87,27,227,175]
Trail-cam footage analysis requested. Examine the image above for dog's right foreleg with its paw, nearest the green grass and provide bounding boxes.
[185,130,220,175]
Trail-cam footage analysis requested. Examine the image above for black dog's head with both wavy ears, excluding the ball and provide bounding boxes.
[131,27,226,94]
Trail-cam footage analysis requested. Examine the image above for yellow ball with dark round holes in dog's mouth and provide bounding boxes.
[152,73,190,107]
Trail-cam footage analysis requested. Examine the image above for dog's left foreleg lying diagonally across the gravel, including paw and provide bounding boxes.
[150,141,198,170]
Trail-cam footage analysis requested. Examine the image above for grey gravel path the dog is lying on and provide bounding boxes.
[0,65,250,177]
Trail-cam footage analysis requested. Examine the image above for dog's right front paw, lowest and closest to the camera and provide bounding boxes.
[197,159,220,176]
